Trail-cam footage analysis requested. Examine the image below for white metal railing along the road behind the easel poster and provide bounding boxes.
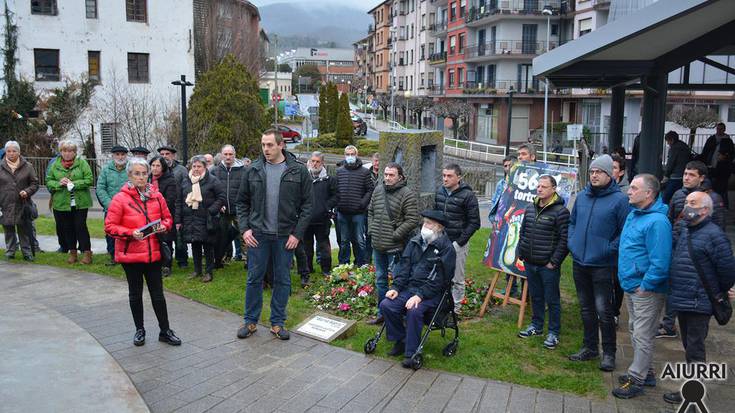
[444,138,578,166]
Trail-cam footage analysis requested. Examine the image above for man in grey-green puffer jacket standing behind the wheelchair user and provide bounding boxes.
[368,162,419,324]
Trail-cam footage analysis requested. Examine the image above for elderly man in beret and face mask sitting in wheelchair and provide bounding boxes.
[380,210,456,368]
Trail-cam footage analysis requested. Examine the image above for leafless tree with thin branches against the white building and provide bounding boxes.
[95,70,172,148]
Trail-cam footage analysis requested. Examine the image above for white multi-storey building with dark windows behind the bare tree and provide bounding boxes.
[2,0,194,156]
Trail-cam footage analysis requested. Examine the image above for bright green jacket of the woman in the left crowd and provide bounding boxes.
[46,157,94,211]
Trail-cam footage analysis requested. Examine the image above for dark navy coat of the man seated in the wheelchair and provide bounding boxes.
[391,233,457,300]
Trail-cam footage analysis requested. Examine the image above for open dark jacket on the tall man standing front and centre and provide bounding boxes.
[235,151,313,240]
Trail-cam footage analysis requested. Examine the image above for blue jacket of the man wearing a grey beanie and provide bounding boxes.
[567,181,630,267]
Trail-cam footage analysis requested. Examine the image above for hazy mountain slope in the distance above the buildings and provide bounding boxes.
[258,3,372,51]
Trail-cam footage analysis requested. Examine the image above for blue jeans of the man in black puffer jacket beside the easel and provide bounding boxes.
[526,263,561,336]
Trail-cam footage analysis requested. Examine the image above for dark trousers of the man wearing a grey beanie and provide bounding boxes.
[573,262,617,355]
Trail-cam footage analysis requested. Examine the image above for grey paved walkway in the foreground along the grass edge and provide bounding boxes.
[0,263,735,413]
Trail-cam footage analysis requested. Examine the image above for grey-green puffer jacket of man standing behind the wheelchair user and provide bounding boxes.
[368,179,419,252]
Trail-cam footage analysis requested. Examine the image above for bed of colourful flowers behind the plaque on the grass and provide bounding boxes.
[308,264,378,320]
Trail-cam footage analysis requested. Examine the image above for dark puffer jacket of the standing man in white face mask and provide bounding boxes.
[337,159,375,215]
